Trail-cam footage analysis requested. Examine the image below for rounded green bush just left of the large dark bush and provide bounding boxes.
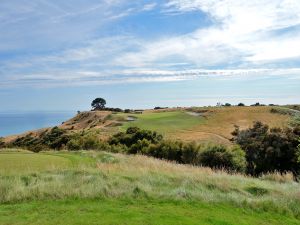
[199,145,246,172]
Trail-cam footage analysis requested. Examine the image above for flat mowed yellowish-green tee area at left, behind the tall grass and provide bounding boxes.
[0,152,71,174]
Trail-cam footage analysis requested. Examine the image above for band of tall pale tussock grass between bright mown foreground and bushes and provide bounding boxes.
[0,151,300,218]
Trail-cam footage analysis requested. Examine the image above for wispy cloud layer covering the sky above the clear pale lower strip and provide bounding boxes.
[0,0,300,87]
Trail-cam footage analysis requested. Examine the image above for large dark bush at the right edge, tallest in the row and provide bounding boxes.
[233,122,300,176]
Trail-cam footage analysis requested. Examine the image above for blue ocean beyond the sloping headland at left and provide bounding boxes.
[0,111,76,137]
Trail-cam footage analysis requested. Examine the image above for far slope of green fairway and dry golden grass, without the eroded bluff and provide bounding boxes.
[122,107,289,144]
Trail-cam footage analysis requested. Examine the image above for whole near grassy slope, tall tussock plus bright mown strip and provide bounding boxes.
[0,152,300,224]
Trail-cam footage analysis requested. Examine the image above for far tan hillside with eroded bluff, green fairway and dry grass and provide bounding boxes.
[6,106,290,144]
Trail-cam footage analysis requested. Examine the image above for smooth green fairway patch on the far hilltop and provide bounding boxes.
[122,111,205,134]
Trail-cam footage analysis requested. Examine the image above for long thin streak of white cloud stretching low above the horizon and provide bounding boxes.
[0,68,300,87]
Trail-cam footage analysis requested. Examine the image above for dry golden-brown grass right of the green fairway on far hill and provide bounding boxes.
[170,106,290,144]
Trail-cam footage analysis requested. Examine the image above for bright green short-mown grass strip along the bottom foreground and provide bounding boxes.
[0,199,300,225]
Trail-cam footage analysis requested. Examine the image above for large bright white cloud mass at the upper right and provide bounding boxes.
[116,0,300,68]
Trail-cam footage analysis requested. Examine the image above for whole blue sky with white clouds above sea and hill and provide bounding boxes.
[0,0,300,111]
